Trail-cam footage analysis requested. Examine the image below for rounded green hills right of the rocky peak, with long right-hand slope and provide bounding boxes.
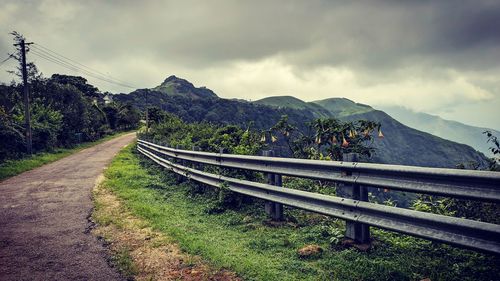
[256,96,485,167]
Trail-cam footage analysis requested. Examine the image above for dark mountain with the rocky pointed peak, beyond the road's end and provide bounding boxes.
[112,79,315,129]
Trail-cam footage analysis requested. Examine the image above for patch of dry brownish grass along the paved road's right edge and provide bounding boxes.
[92,154,241,281]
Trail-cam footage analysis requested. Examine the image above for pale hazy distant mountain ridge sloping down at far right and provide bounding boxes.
[381,106,500,157]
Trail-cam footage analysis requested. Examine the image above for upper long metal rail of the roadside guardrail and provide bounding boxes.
[139,140,500,203]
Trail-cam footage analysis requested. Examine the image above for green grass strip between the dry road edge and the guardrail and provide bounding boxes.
[104,145,500,281]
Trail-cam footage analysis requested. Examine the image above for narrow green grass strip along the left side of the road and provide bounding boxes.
[0,131,132,180]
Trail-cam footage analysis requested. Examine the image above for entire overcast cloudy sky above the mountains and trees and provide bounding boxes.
[0,0,500,129]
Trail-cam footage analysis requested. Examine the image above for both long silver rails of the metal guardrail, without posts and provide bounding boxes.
[138,140,500,254]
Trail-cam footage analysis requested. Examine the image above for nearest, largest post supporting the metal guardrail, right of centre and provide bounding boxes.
[339,153,370,243]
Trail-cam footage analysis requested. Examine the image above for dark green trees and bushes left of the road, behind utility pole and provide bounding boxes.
[0,68,140,162]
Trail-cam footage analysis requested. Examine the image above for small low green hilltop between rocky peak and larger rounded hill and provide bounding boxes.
[254,96,331,118]
